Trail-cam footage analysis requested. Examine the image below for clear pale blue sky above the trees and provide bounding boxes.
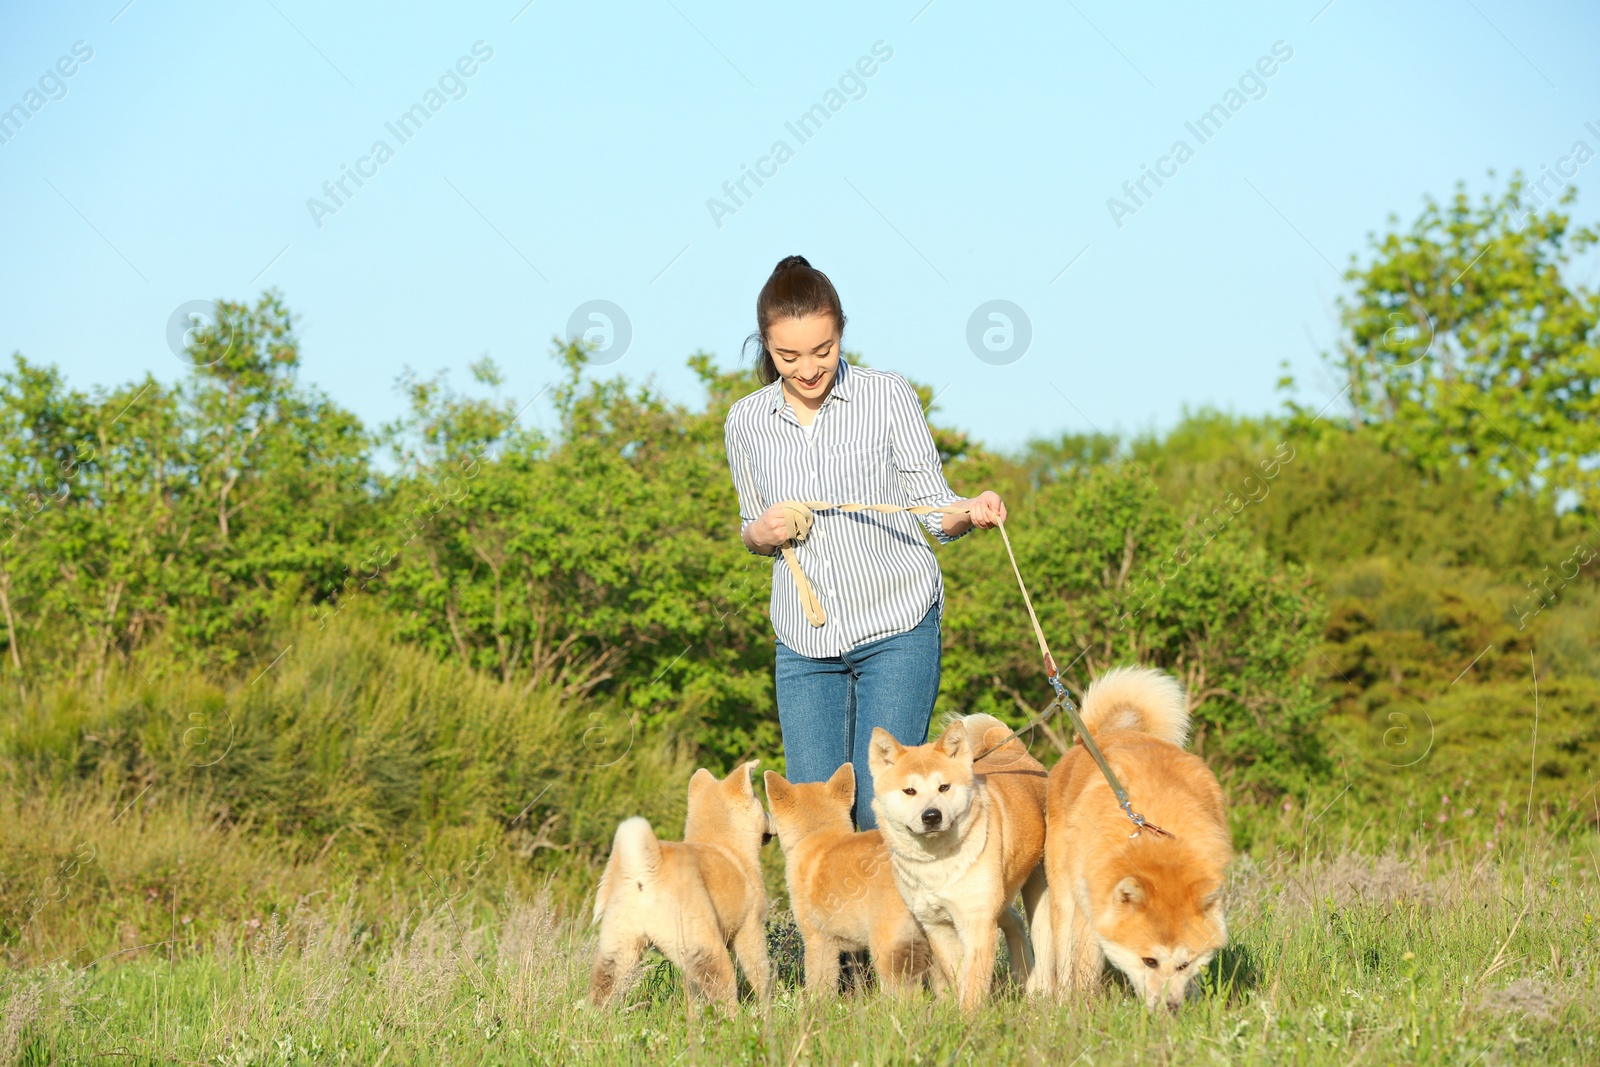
[0,0,1600,448]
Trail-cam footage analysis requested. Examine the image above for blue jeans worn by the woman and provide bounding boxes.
[776,608,939,830]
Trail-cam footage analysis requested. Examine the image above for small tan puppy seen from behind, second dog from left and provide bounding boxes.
[765,763,933,997]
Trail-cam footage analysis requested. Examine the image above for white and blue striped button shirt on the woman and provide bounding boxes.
[725,358,962,659]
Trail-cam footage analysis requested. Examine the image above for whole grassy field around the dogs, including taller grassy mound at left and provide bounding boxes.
[0,625,1600,1067]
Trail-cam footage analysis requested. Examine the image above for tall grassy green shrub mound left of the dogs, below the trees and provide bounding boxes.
[0,609,700,952]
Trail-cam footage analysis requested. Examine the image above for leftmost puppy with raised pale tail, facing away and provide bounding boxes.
[589,760,771,1009]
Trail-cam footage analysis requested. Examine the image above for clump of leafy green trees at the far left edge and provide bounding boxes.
[0,293,373,677]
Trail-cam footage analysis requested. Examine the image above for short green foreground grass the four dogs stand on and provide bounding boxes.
[0,830,1600,1065]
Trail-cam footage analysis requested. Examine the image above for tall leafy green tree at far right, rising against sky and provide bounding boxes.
[1298,174,1600,510]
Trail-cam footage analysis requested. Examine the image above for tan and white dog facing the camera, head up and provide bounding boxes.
[869,715,1046,1013]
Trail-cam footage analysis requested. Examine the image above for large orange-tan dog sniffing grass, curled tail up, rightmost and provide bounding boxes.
[1029,667,1232,1011]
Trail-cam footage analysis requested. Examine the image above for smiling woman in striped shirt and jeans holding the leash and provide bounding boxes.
[725,256,1005,829]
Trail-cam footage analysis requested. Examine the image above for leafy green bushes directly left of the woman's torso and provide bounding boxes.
[369,346,778,761]
